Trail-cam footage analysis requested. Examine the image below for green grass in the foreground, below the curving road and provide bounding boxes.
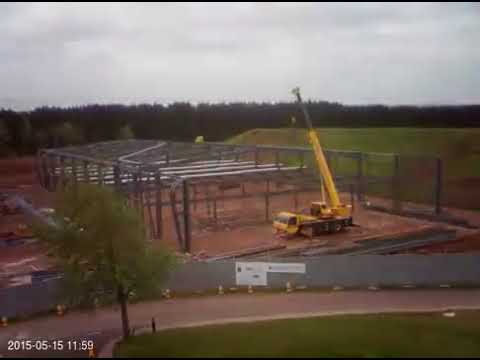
[115,311,480,357]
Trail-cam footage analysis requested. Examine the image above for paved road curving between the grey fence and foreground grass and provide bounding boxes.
[0,289,480,357]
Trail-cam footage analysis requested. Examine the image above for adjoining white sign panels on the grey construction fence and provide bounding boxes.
[235,262,306,286]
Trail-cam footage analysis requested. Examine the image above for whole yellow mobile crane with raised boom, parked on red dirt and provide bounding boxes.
[273,87,353,236]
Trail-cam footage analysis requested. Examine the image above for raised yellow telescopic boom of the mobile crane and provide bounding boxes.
[292,87,341,208]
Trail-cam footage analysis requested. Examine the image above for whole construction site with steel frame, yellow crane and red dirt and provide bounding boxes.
[1,92,480,286]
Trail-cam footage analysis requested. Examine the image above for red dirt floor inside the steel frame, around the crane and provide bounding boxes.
[151,185,480,256]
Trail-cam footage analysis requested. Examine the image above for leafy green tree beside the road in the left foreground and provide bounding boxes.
[34,184,174,338]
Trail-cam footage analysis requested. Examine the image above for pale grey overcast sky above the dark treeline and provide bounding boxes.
[0,3,480,110]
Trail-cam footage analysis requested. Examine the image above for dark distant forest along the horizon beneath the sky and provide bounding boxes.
[0,102,480,156]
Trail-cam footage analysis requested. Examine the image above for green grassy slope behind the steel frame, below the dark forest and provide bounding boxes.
[227,128,480,210]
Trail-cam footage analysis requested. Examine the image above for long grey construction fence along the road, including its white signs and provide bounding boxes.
[0,254,480,318]
